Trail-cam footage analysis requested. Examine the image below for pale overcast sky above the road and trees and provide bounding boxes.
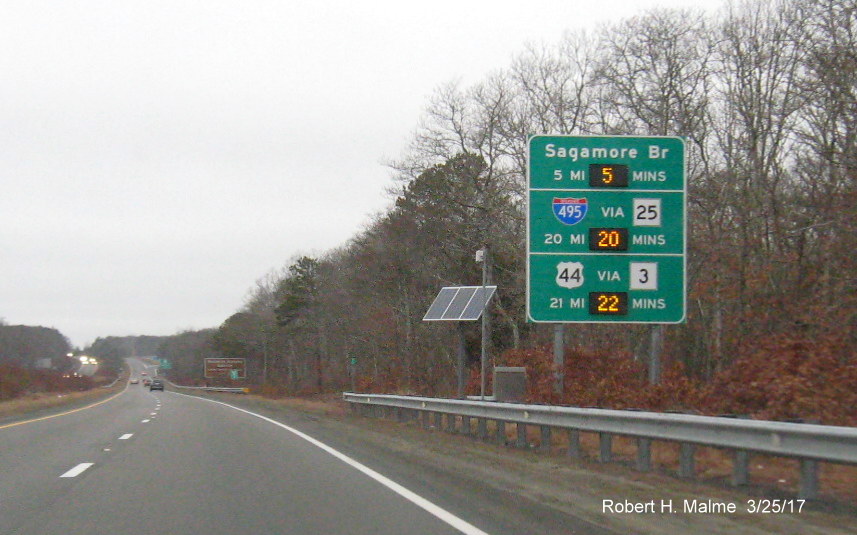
[0,0,721,347]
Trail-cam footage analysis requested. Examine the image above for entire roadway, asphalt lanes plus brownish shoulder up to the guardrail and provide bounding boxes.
[6,359,855,535]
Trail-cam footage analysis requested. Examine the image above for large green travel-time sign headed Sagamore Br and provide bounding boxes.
[527,135,687,323]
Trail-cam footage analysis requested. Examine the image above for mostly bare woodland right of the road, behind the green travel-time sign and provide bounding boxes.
[144,0,844,422]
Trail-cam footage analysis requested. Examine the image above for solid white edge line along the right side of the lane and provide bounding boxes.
[172,392,488,535]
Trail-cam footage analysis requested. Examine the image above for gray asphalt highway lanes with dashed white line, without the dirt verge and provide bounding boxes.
[0,360,604,535]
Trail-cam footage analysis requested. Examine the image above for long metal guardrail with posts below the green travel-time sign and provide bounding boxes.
[343,392,857,498]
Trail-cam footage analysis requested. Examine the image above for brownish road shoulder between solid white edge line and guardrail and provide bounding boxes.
[177,395,857,535]
